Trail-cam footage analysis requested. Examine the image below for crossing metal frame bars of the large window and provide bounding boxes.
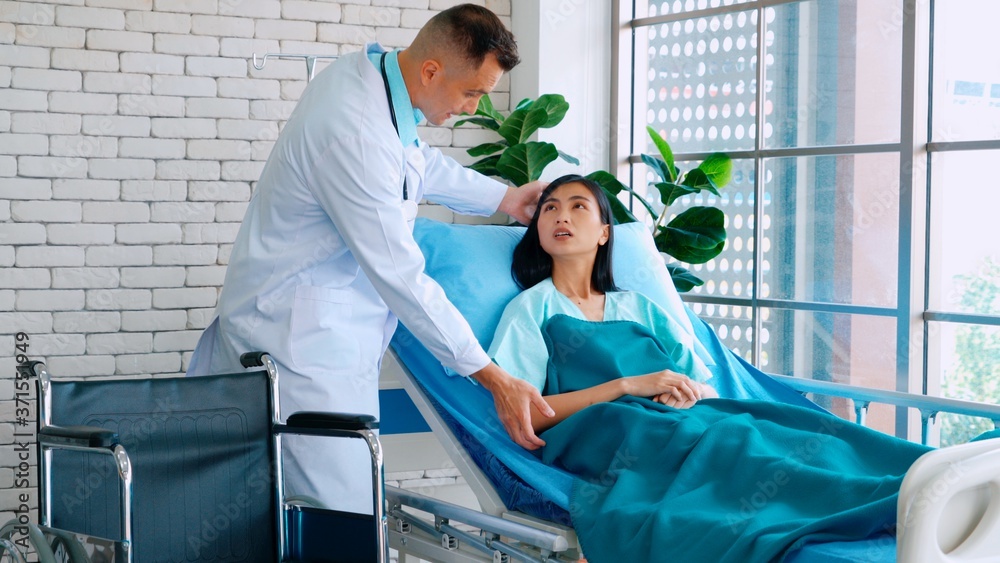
[608,0,1000,439]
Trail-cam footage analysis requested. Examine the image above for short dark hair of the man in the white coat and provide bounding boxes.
[424,4,521,72]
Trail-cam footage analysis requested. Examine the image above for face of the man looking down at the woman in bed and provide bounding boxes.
[420,53,503,125]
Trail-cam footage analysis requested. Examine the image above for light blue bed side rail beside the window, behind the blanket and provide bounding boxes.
[768,374,1000,445]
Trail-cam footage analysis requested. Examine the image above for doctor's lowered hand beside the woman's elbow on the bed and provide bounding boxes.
[472,362,556,450]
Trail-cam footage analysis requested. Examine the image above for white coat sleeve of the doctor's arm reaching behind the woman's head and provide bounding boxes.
[420,141,507,215]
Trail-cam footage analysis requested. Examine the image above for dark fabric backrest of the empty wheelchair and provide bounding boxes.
[49,370,277,563]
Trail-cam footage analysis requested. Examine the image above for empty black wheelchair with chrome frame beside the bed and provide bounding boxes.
[0,352,389,563]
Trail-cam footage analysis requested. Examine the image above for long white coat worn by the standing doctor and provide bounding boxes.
[189,45,506,513]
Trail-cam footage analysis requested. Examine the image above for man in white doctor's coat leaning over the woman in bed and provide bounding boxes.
[189,4,552,513]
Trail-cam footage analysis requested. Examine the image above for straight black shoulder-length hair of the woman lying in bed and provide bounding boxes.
[510,174,618,293]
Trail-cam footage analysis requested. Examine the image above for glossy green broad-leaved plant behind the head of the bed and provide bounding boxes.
[456,94,733,292]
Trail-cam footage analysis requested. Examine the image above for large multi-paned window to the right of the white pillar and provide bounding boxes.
[612,0,1000,443]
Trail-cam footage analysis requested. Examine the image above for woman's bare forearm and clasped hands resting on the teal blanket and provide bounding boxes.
[531,370,718,433]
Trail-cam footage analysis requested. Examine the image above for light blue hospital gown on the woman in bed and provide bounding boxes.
[489,278,712,391]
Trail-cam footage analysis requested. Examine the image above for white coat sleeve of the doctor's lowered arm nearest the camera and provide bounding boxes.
[304,137,490,375]
